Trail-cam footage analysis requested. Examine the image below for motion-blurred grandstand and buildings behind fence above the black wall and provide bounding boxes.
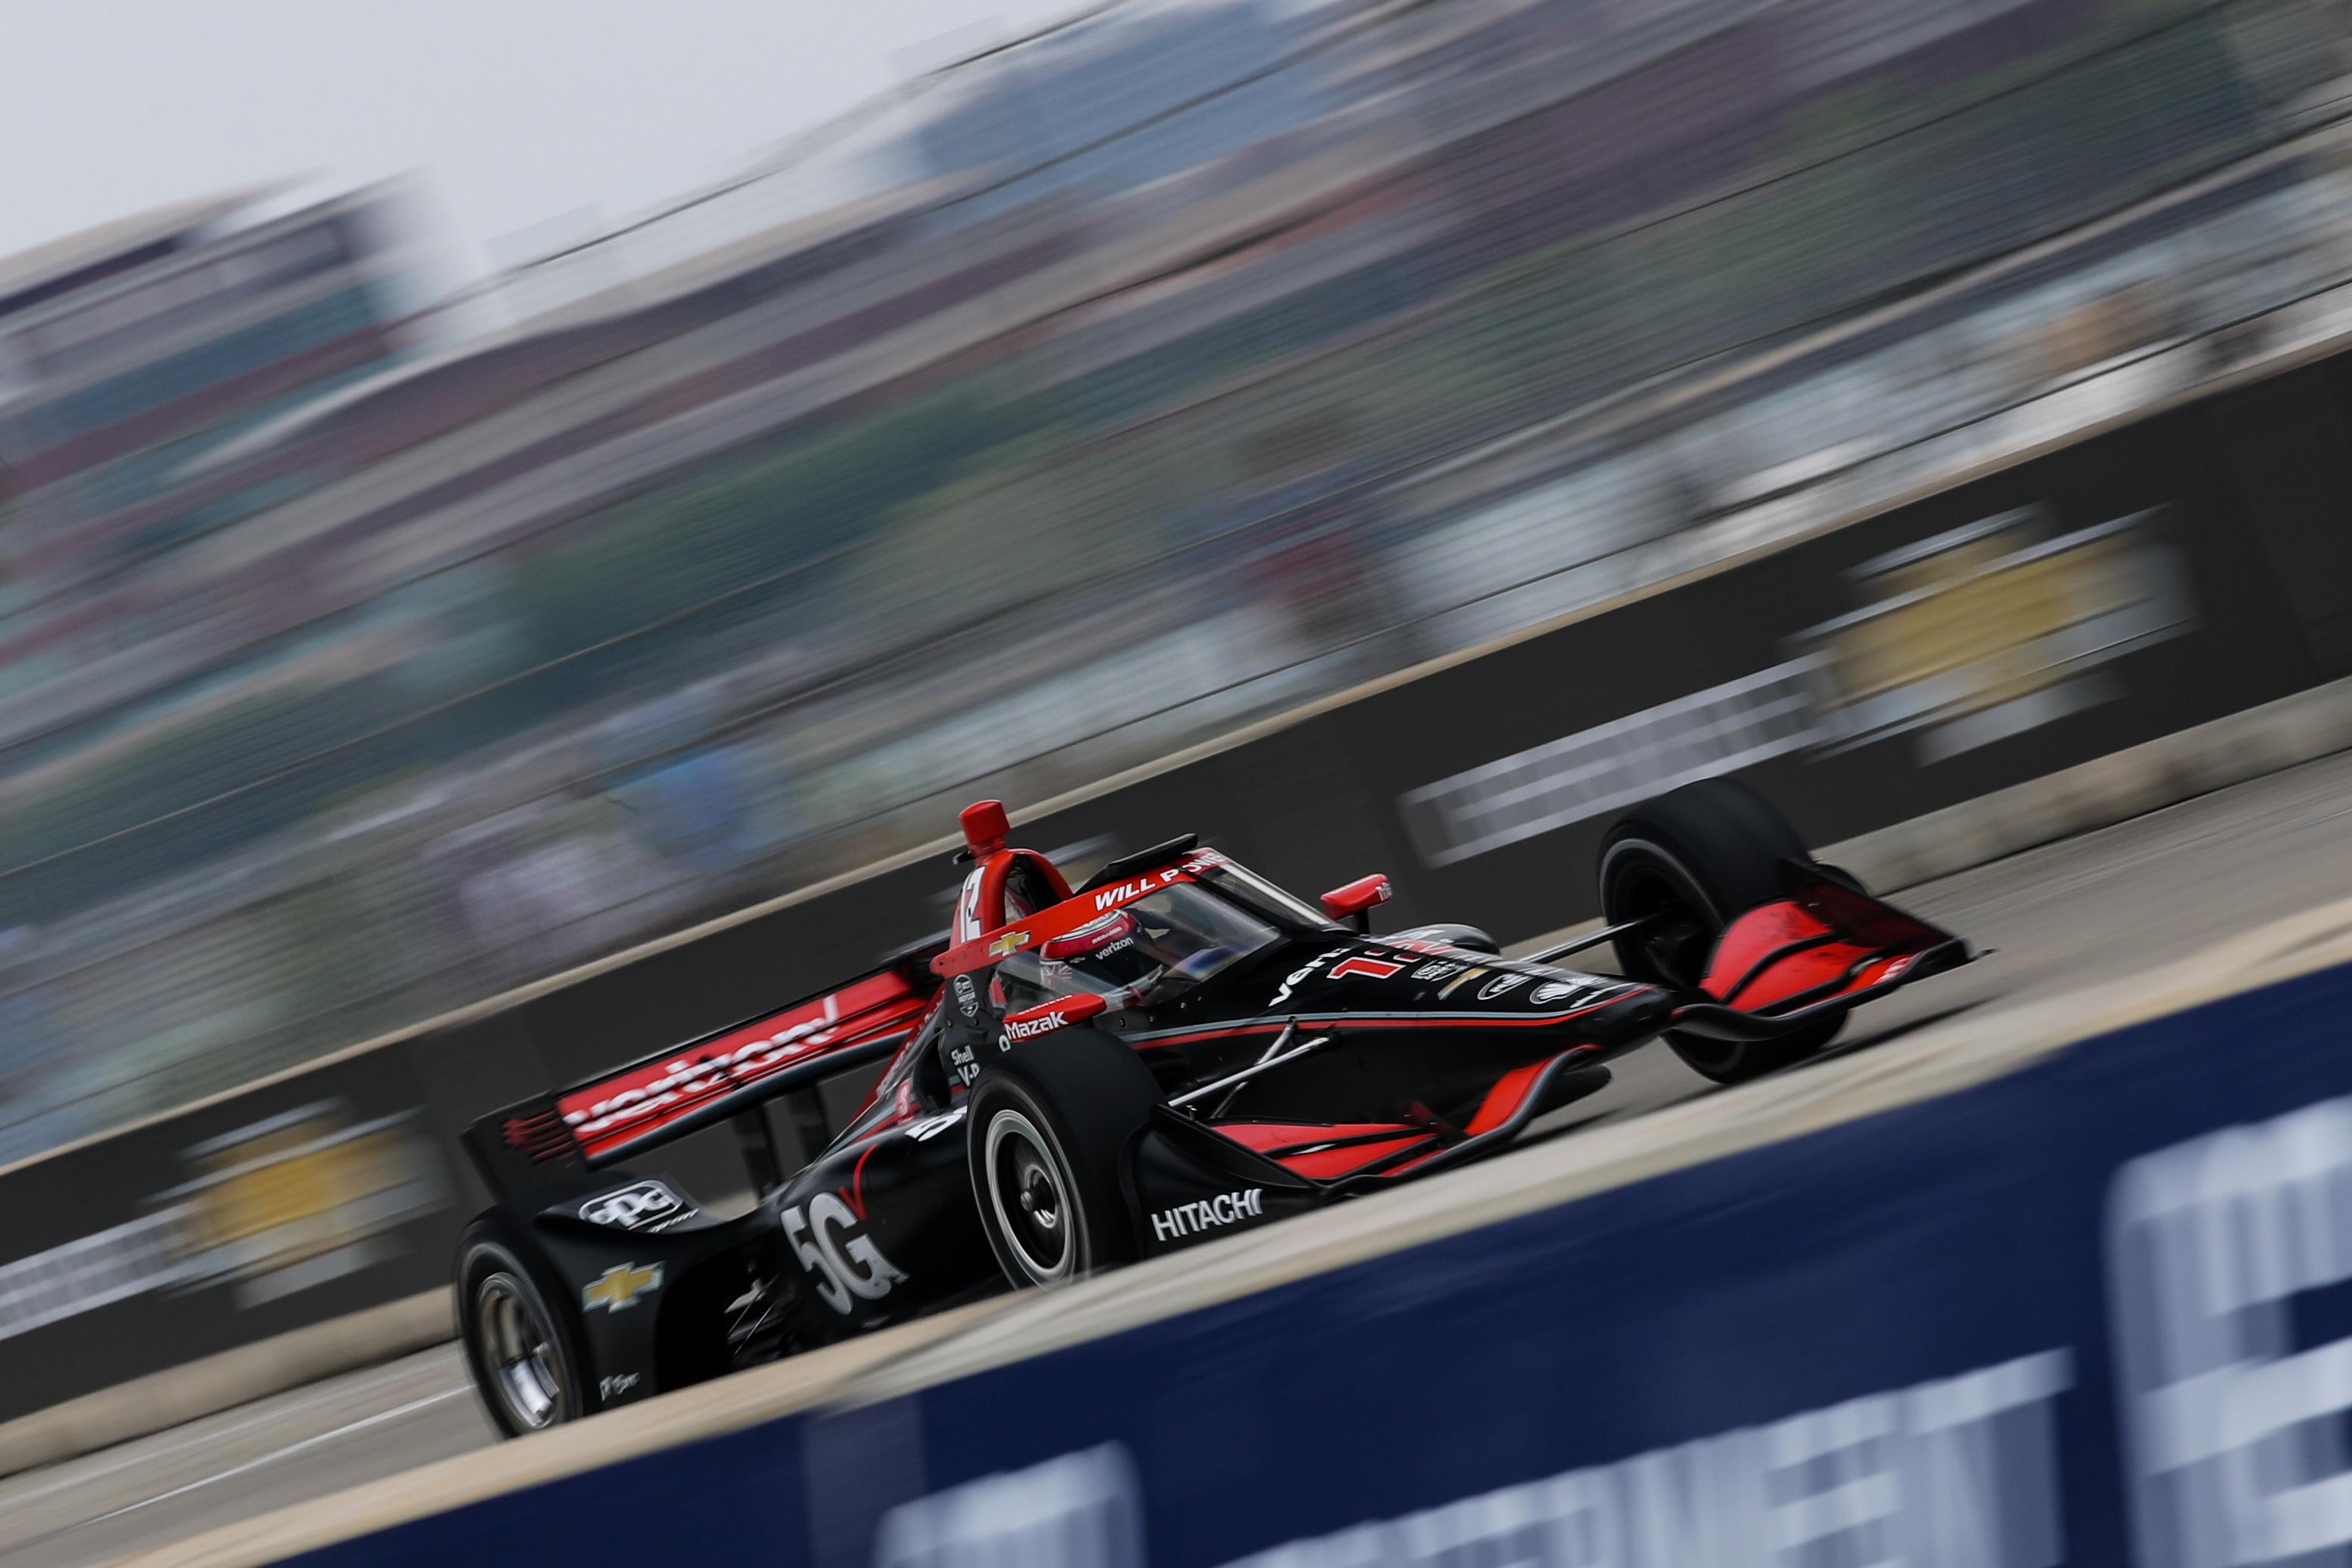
[0,0,2352,1159]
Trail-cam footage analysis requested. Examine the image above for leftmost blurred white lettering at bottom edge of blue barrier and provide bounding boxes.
[872,1443,1146,1568]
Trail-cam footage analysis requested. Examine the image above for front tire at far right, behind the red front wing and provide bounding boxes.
[1600,778,1846,1084]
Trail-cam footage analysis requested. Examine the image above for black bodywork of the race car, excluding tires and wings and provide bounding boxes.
[466,839,1964,1410]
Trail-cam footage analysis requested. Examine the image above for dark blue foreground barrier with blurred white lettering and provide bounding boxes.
[304,968,2352,1568]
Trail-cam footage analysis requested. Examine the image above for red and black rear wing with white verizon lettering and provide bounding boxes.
[466,940,946,1196]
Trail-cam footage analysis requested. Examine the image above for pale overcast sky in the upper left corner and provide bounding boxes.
[0,0,1085,291]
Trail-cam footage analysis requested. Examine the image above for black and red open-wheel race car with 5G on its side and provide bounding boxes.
[456,780,1968,1434]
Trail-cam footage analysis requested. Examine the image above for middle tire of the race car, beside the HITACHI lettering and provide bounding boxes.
[967,1029,1159,1291]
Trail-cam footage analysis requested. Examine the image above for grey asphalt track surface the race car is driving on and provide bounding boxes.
[14,755,2352,1568]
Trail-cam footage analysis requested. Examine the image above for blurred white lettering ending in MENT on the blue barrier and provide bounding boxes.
[1223,1350,2070,1568]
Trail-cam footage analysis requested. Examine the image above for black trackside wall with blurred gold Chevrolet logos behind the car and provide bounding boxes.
[0,315,2352,1462]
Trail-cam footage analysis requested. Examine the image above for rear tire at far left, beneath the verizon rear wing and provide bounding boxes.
[456,1213,595,1437]
